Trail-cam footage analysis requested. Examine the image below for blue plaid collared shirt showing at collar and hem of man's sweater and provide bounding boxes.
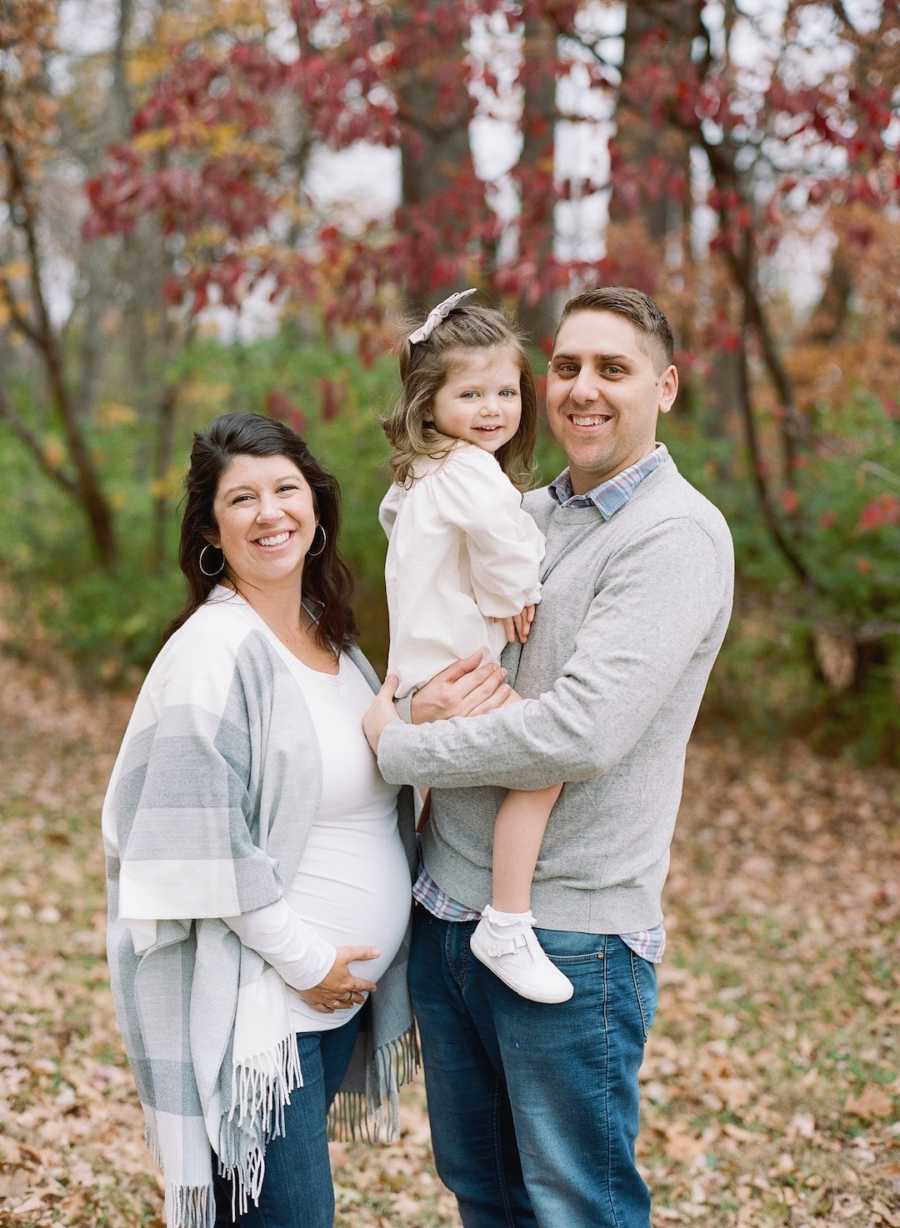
[413,443,669,964]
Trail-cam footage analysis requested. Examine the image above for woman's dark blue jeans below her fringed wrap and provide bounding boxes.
[212,1011,362,1228]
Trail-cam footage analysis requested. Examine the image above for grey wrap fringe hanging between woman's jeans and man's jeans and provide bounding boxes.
[328,1027,421,1143]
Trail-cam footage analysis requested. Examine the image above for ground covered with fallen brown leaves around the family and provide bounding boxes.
[0,656,900,1228]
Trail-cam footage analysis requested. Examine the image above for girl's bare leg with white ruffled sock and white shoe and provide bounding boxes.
[471,785,573,1002]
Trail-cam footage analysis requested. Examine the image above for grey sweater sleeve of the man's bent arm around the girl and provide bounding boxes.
[378,518,727,790]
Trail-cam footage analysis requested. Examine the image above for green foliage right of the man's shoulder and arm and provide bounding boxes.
[663,394,900,761]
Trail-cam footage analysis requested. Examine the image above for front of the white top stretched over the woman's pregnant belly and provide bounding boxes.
[285,653,411,1032]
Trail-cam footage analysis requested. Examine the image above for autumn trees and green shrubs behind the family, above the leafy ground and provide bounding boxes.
[0,0,900,760]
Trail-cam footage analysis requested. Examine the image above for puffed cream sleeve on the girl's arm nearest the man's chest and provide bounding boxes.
[430,445,544,618]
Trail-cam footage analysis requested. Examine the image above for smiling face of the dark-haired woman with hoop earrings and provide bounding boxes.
[210,456,316,588]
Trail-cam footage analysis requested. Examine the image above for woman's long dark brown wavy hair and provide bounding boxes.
[166,414,357,650]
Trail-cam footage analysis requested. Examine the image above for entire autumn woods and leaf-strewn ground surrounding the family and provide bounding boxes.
[0,0,900,1228]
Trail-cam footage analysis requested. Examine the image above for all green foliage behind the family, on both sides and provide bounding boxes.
[0,336,900,760]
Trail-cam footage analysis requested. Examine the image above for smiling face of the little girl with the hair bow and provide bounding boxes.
[431,345,522,453]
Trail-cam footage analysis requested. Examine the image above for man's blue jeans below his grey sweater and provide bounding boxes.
[410,905,657,1228]
